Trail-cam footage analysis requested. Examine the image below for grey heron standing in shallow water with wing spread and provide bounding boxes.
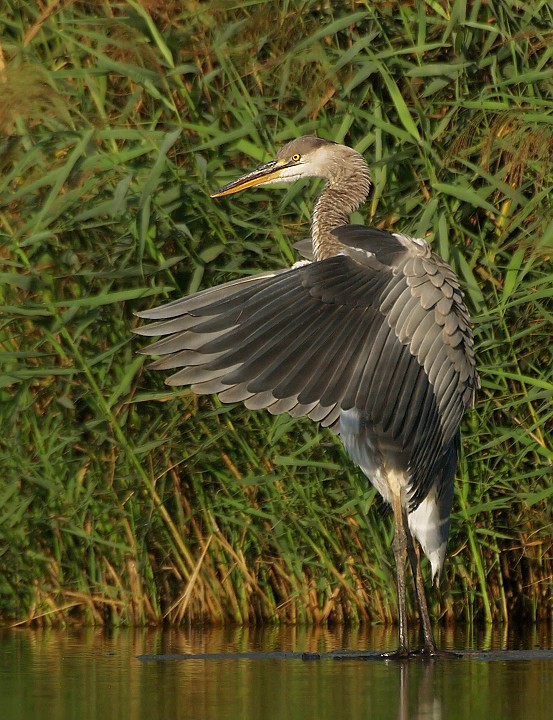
[137,136,478,658]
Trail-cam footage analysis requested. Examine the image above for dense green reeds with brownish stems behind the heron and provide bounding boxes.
[0,0,553,623]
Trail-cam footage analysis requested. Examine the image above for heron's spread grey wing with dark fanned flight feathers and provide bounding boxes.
[138,226,476,500]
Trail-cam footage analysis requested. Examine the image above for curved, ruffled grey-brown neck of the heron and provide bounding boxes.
[311,162,371,260]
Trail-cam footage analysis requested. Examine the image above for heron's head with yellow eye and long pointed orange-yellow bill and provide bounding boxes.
[211,135,366,197]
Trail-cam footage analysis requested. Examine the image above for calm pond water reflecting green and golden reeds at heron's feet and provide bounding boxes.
[0,626,553,720]
